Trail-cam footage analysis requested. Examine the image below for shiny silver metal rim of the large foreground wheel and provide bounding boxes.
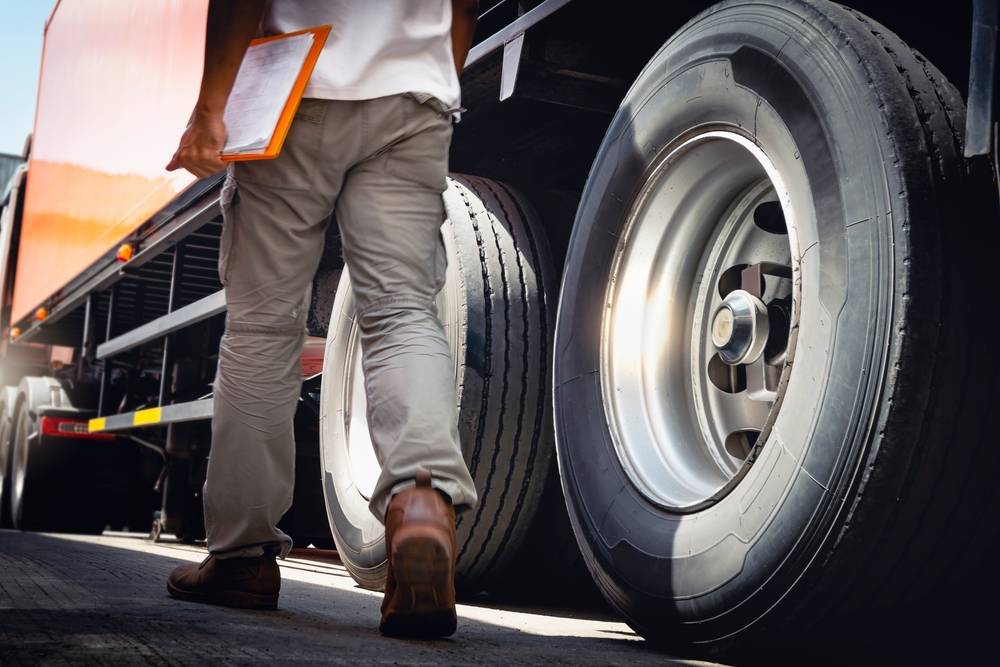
[600,127,799,511]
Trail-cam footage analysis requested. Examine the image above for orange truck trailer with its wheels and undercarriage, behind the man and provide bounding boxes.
[0,0,1000,656]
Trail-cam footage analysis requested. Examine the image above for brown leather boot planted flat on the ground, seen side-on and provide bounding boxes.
[167,554,281,609]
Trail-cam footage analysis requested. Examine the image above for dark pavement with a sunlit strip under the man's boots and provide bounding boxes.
[0,531,720,665]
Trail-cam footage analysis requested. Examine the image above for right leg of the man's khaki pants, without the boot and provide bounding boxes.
[337,95,476,520]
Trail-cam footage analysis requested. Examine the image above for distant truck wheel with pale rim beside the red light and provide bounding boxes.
[11,377,113,534]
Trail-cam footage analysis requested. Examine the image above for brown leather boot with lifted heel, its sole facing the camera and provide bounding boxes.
[379,470,456,637]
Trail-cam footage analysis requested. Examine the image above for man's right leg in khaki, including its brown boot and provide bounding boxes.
[337,95,476,637]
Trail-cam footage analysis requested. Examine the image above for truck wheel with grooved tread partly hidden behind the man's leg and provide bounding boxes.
[320,176,554,592]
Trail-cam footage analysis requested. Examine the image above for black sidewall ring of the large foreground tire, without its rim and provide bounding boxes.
[554,2,894,641]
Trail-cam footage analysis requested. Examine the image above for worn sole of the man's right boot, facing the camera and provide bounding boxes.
[379,526,458,638]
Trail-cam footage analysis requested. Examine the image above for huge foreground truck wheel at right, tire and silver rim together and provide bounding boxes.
[553,0,1000,657]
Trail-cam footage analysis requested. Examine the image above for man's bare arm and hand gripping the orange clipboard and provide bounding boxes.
[167,0,266,178]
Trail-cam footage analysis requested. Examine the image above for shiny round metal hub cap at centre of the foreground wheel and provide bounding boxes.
[712,290,770,366]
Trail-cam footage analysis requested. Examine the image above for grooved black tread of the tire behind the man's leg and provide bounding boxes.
[452,176,554,591]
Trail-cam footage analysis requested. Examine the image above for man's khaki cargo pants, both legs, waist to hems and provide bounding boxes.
[204,94,476,557]
